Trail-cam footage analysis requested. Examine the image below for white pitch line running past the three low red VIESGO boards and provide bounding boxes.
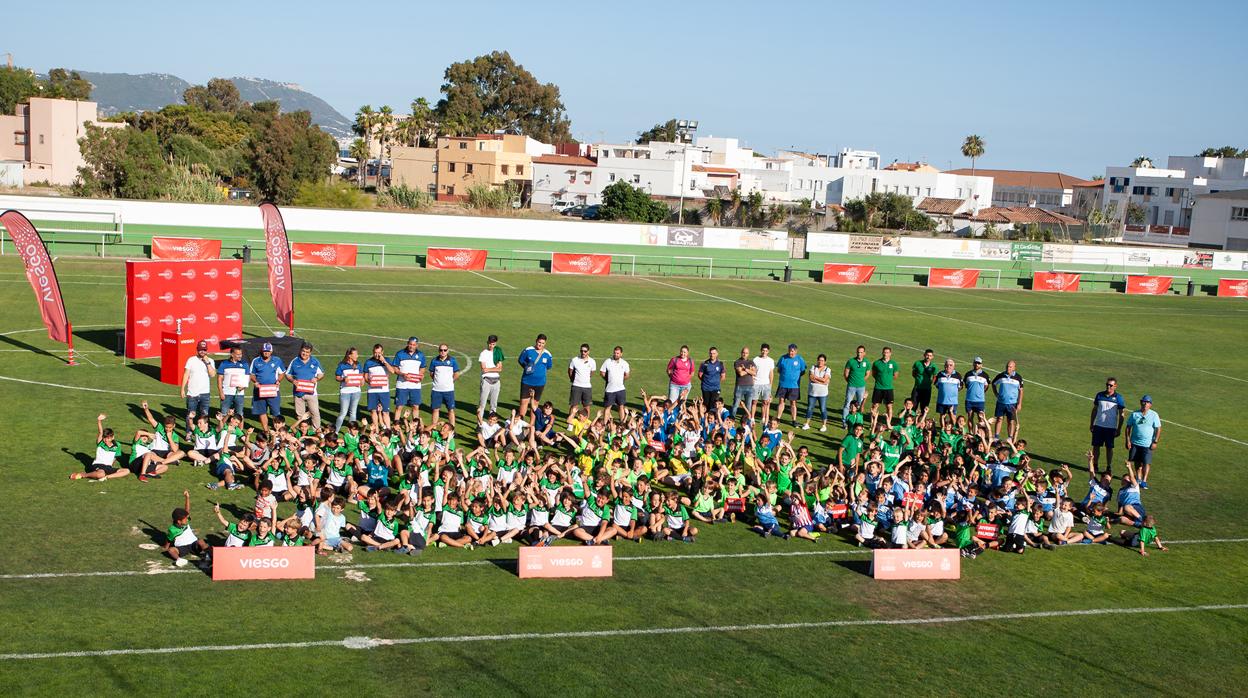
[0,538,1248,581]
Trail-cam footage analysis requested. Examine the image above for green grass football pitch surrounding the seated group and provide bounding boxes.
[0,257,1248,696]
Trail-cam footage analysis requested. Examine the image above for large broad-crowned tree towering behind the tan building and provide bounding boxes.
[434,51,572,142]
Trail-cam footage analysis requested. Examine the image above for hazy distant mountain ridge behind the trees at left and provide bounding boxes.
[77,70,352,137]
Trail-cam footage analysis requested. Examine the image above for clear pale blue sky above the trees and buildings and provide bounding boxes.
[7,0,1248,177]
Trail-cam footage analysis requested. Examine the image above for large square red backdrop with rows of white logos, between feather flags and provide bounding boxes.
[126,260,242,358]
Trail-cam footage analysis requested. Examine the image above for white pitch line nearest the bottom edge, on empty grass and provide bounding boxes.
[0,603,1248,662]
